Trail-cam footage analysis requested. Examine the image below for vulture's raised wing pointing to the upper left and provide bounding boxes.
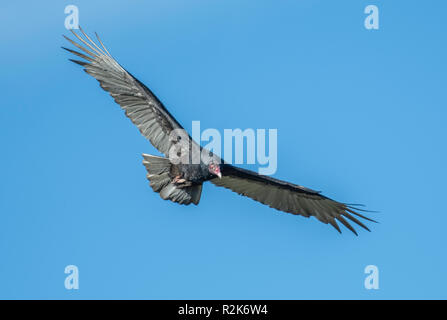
[63,29,191,156]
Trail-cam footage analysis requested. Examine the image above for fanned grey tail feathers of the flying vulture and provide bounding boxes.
[143,153,202,204]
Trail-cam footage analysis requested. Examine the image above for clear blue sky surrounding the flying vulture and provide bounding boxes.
[0,0,447,299]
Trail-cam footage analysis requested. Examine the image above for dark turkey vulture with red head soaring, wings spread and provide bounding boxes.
[63,29,375,235]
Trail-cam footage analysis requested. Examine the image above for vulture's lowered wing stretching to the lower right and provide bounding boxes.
[211,164,375,235]
